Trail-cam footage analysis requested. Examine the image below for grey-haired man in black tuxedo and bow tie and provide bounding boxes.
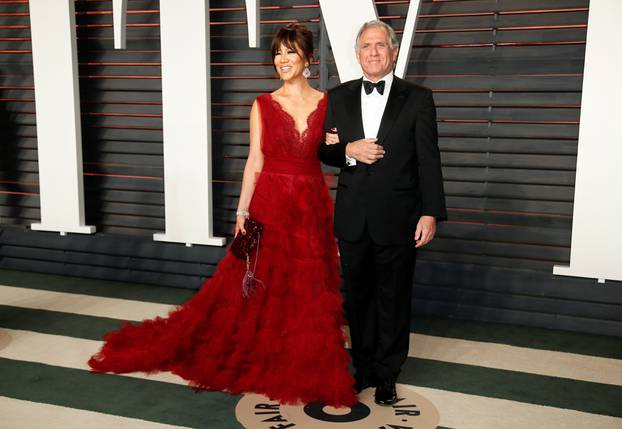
[319,21,447,405]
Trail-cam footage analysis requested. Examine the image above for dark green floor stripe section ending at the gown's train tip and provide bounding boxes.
[0,305,121,340]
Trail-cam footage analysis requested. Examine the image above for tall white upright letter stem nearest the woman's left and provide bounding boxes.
[153,0,225,246]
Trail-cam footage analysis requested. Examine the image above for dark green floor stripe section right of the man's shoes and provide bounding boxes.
[398,358,622,417]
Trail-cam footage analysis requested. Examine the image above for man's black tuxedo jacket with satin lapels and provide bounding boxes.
[319,76,447,245]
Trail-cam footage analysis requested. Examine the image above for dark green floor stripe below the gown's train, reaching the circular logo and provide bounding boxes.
[0,358,242,429]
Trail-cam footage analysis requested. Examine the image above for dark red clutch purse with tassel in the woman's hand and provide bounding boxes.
[230,218,264,298]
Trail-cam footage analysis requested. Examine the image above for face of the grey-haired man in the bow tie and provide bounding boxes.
[356,27,398,81]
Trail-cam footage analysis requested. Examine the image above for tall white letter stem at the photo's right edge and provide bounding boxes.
[553,0,622,281]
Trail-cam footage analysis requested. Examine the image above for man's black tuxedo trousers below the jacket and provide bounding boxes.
[339,232,416,381]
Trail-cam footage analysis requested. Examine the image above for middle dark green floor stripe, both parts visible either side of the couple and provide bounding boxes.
[0,307,622,417]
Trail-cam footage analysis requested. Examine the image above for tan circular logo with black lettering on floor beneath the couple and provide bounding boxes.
[235,384,440,429]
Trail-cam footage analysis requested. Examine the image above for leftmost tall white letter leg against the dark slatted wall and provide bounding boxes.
[29,0,95,234]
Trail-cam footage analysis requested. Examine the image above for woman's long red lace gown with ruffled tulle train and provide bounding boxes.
[88,94,357,406]
